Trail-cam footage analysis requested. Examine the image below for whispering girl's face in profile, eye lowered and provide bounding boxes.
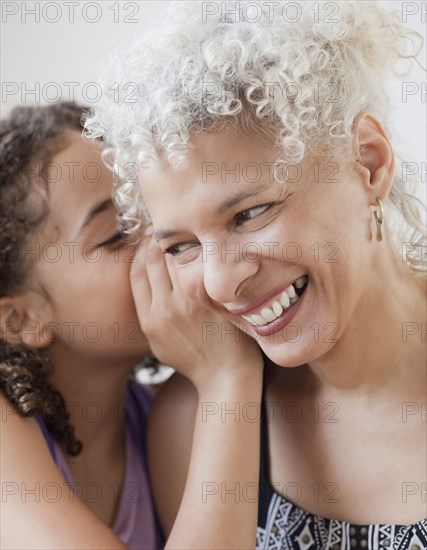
[26,131,149,362]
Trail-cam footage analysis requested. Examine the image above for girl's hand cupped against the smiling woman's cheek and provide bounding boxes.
[130,233,263,390]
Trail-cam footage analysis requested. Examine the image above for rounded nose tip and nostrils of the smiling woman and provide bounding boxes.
[203,242,260,305]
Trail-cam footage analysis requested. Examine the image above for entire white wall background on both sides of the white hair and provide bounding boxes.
[0,0,427,175]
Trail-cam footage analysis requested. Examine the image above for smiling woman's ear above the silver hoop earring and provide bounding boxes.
[353,113,395,205]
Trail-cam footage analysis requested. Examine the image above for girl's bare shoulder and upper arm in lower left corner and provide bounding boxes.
[0,391,124,550]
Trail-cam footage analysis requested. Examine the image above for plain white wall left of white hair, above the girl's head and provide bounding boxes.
[1,0,169,116]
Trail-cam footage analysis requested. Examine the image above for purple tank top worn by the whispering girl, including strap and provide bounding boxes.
[37,381,164,550]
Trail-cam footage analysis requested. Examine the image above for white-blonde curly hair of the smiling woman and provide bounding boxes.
[85,0,426,274]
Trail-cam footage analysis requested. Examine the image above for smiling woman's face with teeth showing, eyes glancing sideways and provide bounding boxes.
[140,131,374,366]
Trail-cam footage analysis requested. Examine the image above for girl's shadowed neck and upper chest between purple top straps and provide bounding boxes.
[47,356,140,527]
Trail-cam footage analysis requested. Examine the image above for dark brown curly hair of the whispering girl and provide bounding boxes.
[0,102,158,456]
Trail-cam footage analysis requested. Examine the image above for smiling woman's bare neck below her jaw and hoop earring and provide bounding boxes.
[309,249,426,396]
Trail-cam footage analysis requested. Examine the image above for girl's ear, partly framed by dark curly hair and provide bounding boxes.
[0,296,54,349]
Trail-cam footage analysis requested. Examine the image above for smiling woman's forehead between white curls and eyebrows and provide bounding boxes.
[139,131,328,215]
